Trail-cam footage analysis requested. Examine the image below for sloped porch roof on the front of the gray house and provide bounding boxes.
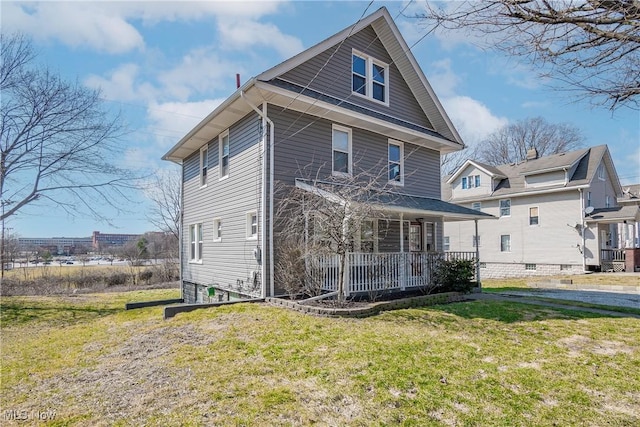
[296,179,496,221]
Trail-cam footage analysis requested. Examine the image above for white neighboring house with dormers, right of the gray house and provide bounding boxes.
[442,145,639,278]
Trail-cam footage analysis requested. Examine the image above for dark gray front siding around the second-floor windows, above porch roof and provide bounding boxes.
[271,108,440,199]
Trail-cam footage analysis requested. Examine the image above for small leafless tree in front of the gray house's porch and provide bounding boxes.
[275,168,393,302]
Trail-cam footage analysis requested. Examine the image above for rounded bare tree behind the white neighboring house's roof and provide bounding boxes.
[477,117,583,166]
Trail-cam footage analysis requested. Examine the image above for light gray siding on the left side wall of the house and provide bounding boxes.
[183,113,262,295]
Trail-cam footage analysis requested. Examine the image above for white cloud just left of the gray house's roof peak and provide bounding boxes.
[218,20,303,58]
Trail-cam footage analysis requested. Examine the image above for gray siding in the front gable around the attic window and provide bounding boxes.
[280,27,434,129]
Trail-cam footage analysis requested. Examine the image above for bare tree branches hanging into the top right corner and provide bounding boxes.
[415,0,640,109]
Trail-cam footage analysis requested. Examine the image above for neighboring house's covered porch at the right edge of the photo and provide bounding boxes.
[585,205,640,272]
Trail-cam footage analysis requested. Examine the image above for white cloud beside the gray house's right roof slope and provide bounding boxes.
[442,96,509,143]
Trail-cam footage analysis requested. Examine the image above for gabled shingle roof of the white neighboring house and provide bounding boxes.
[442,145,622,203]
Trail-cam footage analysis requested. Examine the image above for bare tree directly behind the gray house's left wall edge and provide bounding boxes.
[145,169,182,241]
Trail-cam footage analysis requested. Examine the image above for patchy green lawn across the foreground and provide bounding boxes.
[0,290,640,426]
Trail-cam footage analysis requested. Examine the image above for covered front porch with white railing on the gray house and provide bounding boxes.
[296,182,494,296]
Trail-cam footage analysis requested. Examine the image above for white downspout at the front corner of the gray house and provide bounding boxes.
[240,91,274,298]
